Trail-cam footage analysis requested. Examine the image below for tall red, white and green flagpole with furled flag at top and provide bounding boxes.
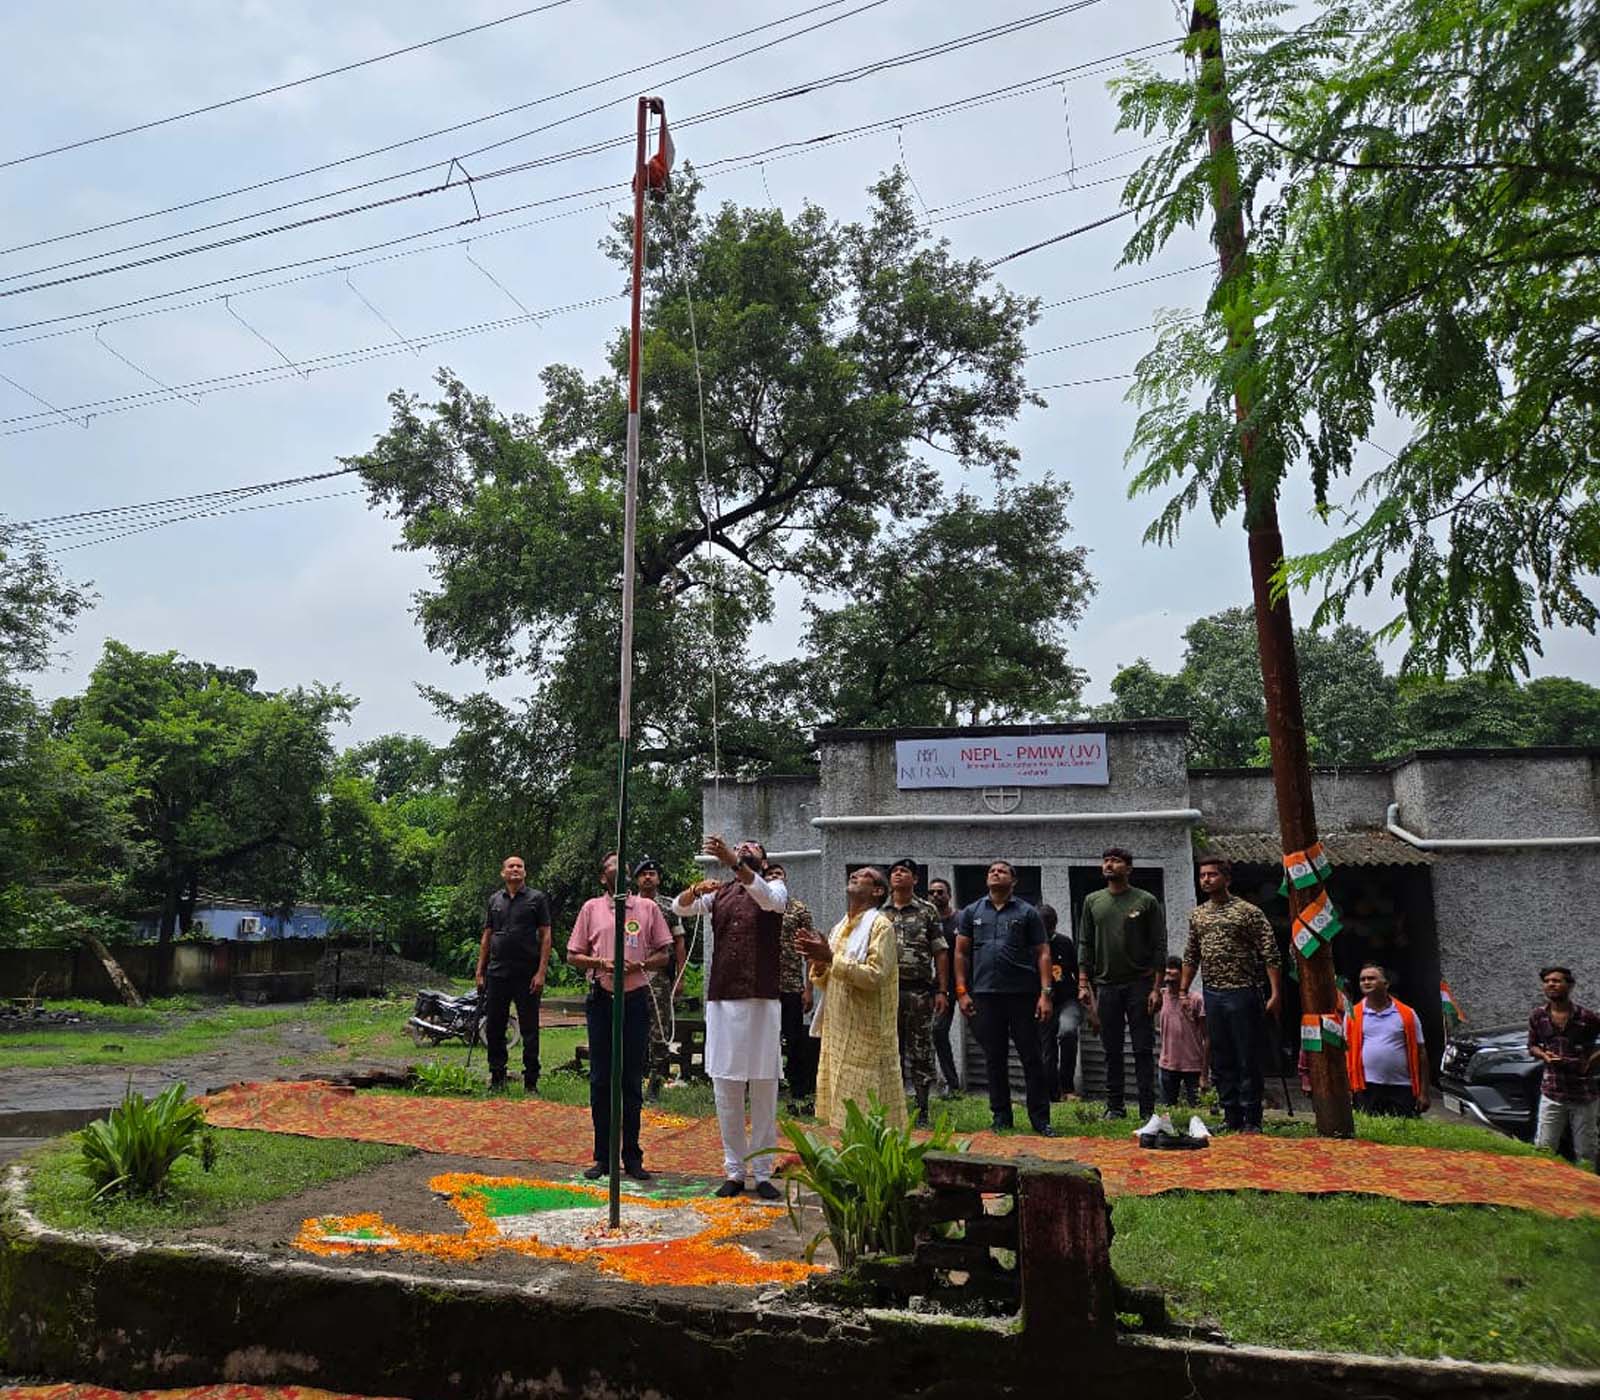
[610,98,674,1229]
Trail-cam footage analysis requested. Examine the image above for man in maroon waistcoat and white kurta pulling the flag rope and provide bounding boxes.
[674,837,789,1200]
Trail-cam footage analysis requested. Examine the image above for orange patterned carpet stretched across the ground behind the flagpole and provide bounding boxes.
[202,1082,1600,1218]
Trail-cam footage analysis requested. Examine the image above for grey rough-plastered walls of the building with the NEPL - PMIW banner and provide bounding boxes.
[706,739,1600,1026]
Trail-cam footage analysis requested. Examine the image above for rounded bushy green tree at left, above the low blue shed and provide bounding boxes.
[67,642,352,970]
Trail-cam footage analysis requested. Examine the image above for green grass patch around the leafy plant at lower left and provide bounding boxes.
[27,1128,413,1235]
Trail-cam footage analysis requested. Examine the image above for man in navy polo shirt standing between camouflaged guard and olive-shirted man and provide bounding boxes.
[955,861,1056,1138]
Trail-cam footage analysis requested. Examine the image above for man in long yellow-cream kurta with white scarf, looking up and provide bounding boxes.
[795,866,906,1128]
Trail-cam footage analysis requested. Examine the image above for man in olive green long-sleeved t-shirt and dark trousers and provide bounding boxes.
[1078,846,1166,1122]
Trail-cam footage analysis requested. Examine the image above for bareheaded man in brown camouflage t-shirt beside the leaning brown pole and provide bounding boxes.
[1179,856,1283,1133]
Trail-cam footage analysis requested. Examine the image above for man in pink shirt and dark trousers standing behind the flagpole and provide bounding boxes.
[566,851,672,1181]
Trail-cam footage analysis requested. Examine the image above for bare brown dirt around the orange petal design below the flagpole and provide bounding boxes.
[173,1152,832,1294]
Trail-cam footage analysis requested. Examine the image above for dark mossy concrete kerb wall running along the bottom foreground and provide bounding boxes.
[0,1168,1600,1400]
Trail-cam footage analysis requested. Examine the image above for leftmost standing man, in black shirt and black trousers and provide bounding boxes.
[478,856,550,1093]
